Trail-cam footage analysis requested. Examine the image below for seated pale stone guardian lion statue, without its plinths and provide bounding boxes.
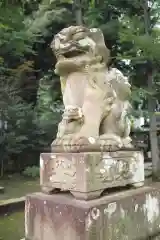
[51,26,132,152]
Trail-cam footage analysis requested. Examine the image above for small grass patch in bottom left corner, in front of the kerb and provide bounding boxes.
[0,212,24,240]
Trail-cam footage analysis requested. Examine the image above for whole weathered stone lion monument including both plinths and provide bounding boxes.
[25,26,148,240]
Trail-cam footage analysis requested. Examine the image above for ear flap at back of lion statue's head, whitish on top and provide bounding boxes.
[90,28,110,64]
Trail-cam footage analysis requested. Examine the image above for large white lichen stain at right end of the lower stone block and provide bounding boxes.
[143,194,160,223]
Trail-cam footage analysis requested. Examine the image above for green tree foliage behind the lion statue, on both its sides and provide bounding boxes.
[0,0,160,174]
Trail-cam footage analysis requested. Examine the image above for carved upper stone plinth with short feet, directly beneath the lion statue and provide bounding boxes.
[40,151,144,200]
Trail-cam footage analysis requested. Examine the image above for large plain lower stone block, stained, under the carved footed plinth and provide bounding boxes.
[25,184,160,240]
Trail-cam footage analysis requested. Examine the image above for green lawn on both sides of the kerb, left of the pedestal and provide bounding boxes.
[0,175,40,240]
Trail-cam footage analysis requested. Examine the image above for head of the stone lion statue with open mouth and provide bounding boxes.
[51,26,110,76]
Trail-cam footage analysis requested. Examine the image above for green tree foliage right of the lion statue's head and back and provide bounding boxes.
[85,0,160,114]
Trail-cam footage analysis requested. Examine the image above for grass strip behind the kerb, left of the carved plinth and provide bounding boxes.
[0,175,40,203]
